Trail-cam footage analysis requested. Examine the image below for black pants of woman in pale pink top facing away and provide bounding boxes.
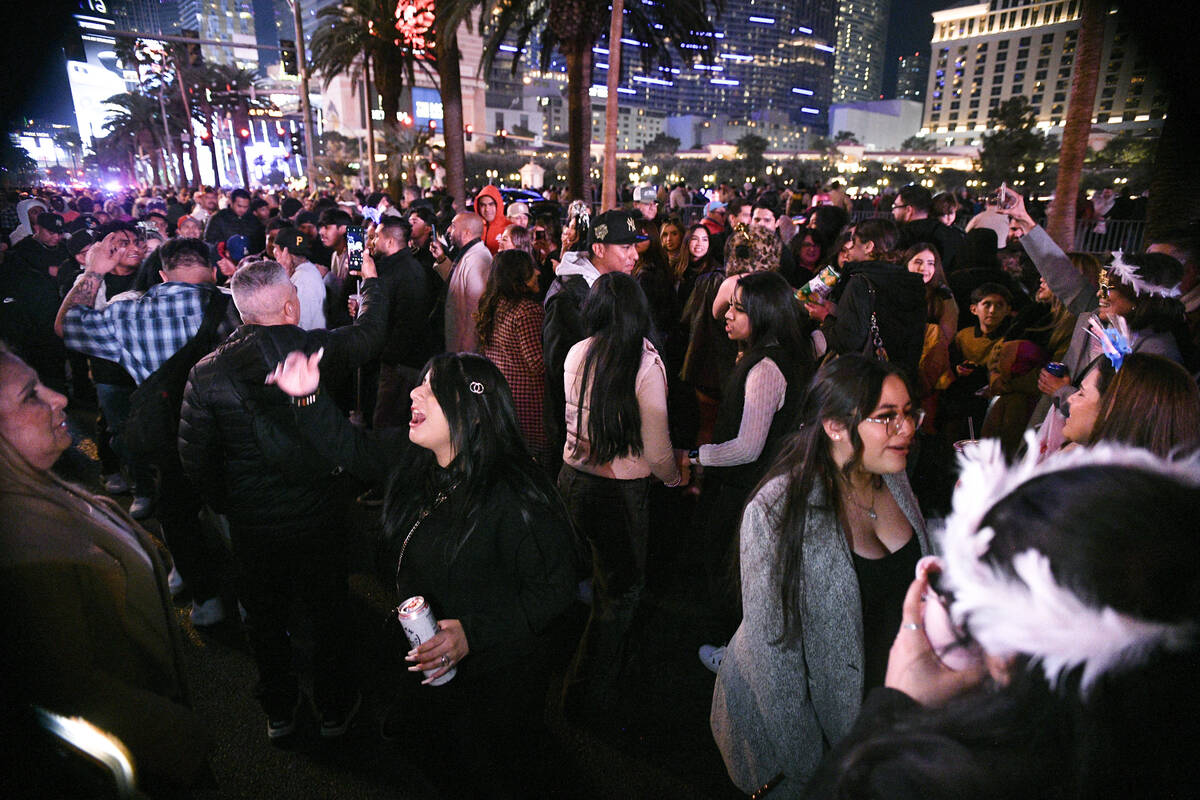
[558,464,650,714]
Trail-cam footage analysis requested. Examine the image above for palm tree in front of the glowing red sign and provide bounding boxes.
[311,0,419,198]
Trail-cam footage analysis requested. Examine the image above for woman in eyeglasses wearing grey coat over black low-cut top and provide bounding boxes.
[710,355,929,800]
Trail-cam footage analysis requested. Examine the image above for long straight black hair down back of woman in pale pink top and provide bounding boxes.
[576,272,650,464]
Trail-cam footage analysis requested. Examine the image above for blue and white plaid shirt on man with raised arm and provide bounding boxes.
[62,282,228,384]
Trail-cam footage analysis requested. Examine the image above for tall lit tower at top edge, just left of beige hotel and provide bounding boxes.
[833,0,892,103]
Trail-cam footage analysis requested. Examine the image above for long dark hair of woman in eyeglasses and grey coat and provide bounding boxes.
[755,354,916,644]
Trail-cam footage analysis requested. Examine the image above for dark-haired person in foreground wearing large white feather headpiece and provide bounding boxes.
[810,440,1200,800]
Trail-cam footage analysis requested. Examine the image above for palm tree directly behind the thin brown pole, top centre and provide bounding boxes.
[463,0,725,198]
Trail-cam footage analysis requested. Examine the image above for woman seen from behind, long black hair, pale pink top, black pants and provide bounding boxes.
[558,272,685,715]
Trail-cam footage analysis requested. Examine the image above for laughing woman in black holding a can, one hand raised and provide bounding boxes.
[272,351,575,796]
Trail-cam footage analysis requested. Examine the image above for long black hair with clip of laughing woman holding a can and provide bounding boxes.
[383,353,566,554]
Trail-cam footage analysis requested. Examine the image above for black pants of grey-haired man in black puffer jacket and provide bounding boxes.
[230,521,356,717]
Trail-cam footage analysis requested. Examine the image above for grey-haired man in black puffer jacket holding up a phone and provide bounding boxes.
[179,255,388,739]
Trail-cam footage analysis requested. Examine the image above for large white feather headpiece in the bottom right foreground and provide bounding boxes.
[941,434,1200,693]
